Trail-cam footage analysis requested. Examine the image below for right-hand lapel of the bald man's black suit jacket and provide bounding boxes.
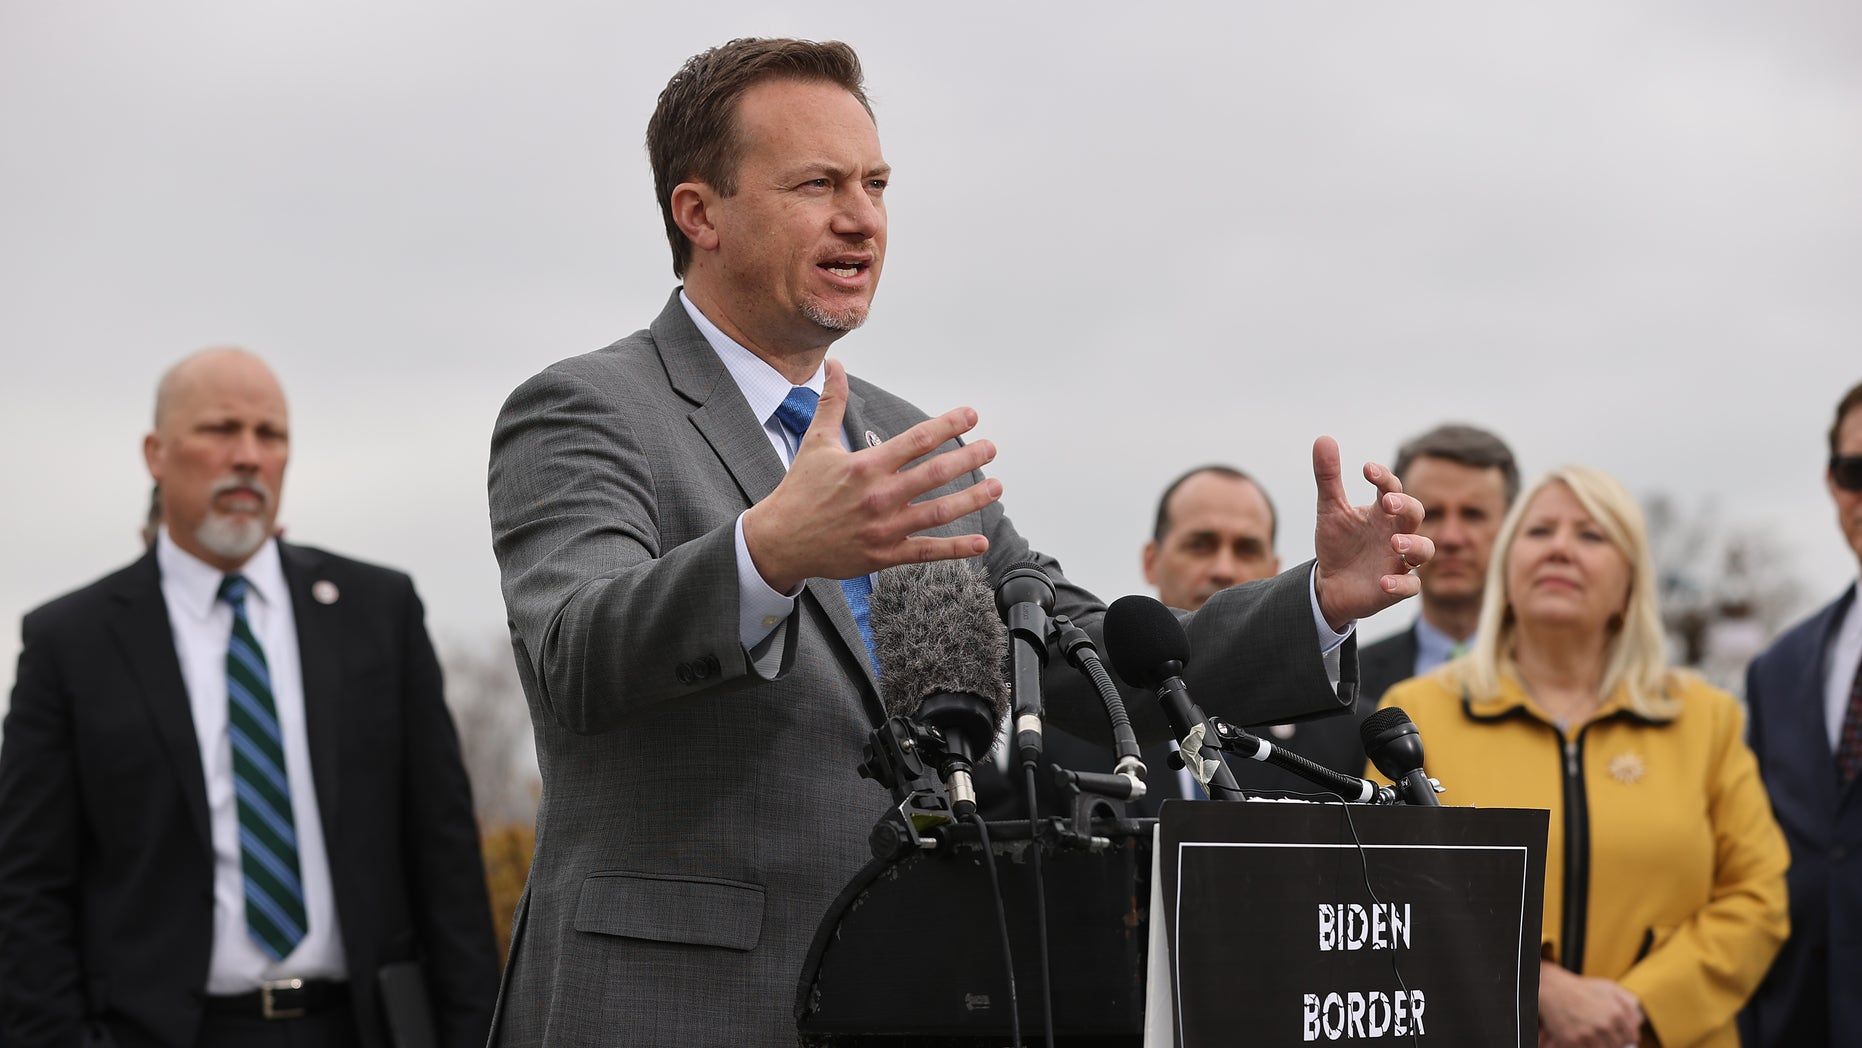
[277,542,344,851]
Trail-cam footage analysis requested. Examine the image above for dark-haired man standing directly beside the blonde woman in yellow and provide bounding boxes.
[1357,423,1519,711]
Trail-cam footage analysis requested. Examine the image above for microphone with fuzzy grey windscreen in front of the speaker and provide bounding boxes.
[871,560,1009,819]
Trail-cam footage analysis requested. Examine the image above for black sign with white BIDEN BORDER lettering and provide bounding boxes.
[1153,802,1547,1048]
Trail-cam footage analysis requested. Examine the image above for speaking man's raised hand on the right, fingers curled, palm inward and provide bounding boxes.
[1313,437,1436,631]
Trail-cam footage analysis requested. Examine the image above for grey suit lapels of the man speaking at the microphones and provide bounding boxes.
[652,292,883,720]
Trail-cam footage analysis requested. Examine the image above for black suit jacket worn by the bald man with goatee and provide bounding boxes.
[0,544,497,1048]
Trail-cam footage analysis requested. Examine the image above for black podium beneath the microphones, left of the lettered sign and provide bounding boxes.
[795,819,1156,1048]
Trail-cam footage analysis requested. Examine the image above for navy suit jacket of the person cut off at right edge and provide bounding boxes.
[1741,586,1862,1048]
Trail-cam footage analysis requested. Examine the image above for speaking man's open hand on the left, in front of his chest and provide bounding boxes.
[743,359,1002,594]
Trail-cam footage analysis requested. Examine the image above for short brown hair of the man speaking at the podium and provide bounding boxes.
[646,37,873,277]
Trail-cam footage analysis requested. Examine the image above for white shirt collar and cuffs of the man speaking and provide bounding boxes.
[680,289,1356,658]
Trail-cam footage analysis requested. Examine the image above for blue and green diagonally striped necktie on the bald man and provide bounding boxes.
[220,575,311,961]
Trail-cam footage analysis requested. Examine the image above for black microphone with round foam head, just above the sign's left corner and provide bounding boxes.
[1106,594,1242,800]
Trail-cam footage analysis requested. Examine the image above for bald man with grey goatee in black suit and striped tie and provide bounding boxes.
[0,348,497,1048]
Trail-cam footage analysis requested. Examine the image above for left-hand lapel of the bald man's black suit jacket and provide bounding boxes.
[110,551,212,849]
